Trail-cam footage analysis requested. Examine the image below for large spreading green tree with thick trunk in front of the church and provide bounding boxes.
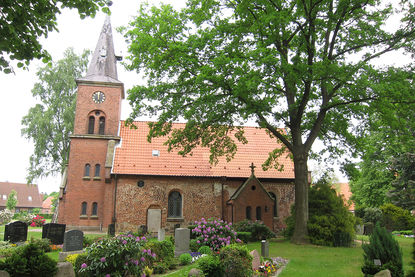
[124,0,415,242]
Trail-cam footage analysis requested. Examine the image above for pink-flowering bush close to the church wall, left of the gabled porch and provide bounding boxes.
[192,218,241,251]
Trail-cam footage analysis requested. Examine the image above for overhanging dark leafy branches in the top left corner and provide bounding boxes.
[0,0,108,73]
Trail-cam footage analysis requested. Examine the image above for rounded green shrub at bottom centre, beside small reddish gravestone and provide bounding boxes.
[219,244,253,277]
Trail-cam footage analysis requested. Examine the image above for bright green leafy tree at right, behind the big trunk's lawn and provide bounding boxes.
[345,69,415,207]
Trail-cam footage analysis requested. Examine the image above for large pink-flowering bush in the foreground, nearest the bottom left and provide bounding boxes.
[79,234,156,276]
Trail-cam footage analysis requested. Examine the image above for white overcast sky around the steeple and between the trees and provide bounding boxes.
[0,0,408,193]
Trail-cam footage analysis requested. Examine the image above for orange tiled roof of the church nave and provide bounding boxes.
[112,121,294,179]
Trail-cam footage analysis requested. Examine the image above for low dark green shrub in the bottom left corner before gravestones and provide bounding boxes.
[0,240,58,277]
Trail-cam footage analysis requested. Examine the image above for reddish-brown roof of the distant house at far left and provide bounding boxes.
[0,182,42,208]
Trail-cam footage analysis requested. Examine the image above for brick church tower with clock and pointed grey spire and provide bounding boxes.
[58,16,124,230]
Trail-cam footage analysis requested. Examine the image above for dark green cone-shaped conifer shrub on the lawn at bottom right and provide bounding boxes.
[362,224,403,277]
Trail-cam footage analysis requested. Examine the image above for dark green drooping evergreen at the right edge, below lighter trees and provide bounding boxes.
[388,153,415,210]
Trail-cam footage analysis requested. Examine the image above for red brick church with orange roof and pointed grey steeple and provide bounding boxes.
[58,18,294,232]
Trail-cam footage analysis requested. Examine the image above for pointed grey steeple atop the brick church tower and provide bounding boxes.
[79,16,121,83]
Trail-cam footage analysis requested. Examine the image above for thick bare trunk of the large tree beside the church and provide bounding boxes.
[291,153,309,244]
